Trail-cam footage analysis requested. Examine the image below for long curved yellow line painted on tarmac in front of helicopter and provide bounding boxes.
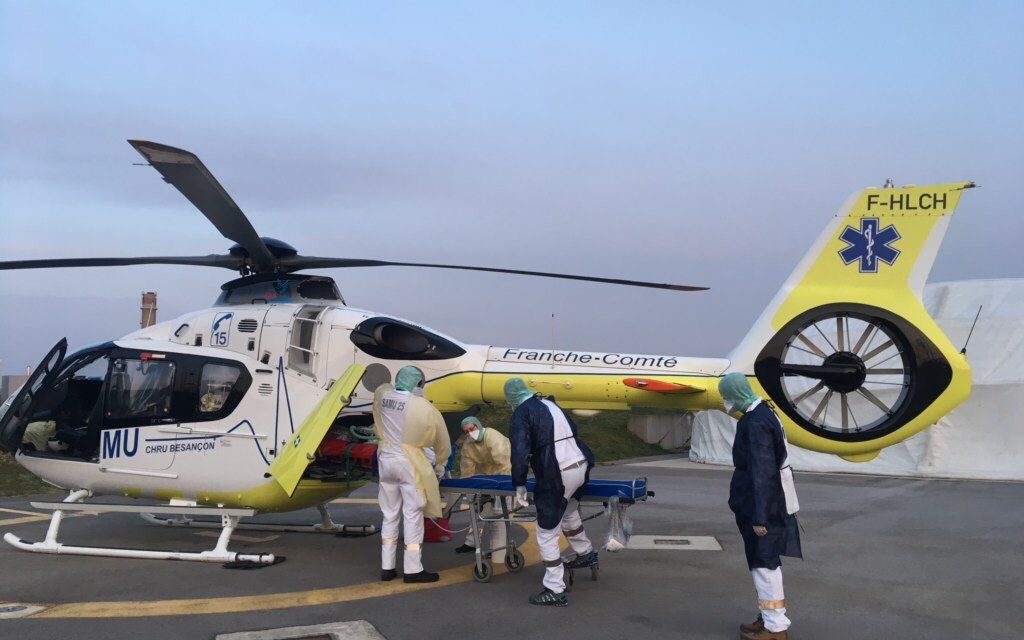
[29,524,541,620]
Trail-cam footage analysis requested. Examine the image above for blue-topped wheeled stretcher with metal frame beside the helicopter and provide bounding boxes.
[439,475,654,585]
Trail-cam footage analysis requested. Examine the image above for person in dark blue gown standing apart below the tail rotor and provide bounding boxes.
[718,373,802,640]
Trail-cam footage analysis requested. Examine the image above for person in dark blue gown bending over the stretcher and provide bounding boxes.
[505,378,597,606]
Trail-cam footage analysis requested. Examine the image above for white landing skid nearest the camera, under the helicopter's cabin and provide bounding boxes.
[3,489,278,565]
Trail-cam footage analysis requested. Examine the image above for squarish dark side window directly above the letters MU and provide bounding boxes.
[105,357,174,420]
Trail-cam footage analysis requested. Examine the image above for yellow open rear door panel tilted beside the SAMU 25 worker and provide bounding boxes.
[267,365,367,498]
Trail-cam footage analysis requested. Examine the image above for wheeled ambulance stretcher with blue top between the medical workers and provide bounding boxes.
[440,475,654,583]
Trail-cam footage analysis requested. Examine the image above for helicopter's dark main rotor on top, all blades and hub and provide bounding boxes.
[0,140,707,291]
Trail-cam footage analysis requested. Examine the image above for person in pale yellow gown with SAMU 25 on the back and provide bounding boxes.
[374,367,452,583]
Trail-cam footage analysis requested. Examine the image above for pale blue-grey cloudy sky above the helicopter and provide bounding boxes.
[0,0,1024,373]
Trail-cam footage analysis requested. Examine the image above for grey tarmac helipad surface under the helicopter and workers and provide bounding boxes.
[0,458,1024,640]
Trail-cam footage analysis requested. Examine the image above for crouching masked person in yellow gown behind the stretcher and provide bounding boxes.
[455,416,512,563]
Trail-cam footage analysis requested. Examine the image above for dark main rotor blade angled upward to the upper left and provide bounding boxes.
[128,140,275,272]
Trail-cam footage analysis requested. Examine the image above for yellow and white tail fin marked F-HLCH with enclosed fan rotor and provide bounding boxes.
[730,182,974,460]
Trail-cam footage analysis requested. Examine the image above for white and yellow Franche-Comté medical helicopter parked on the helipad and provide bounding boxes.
[0,140,974,564]
